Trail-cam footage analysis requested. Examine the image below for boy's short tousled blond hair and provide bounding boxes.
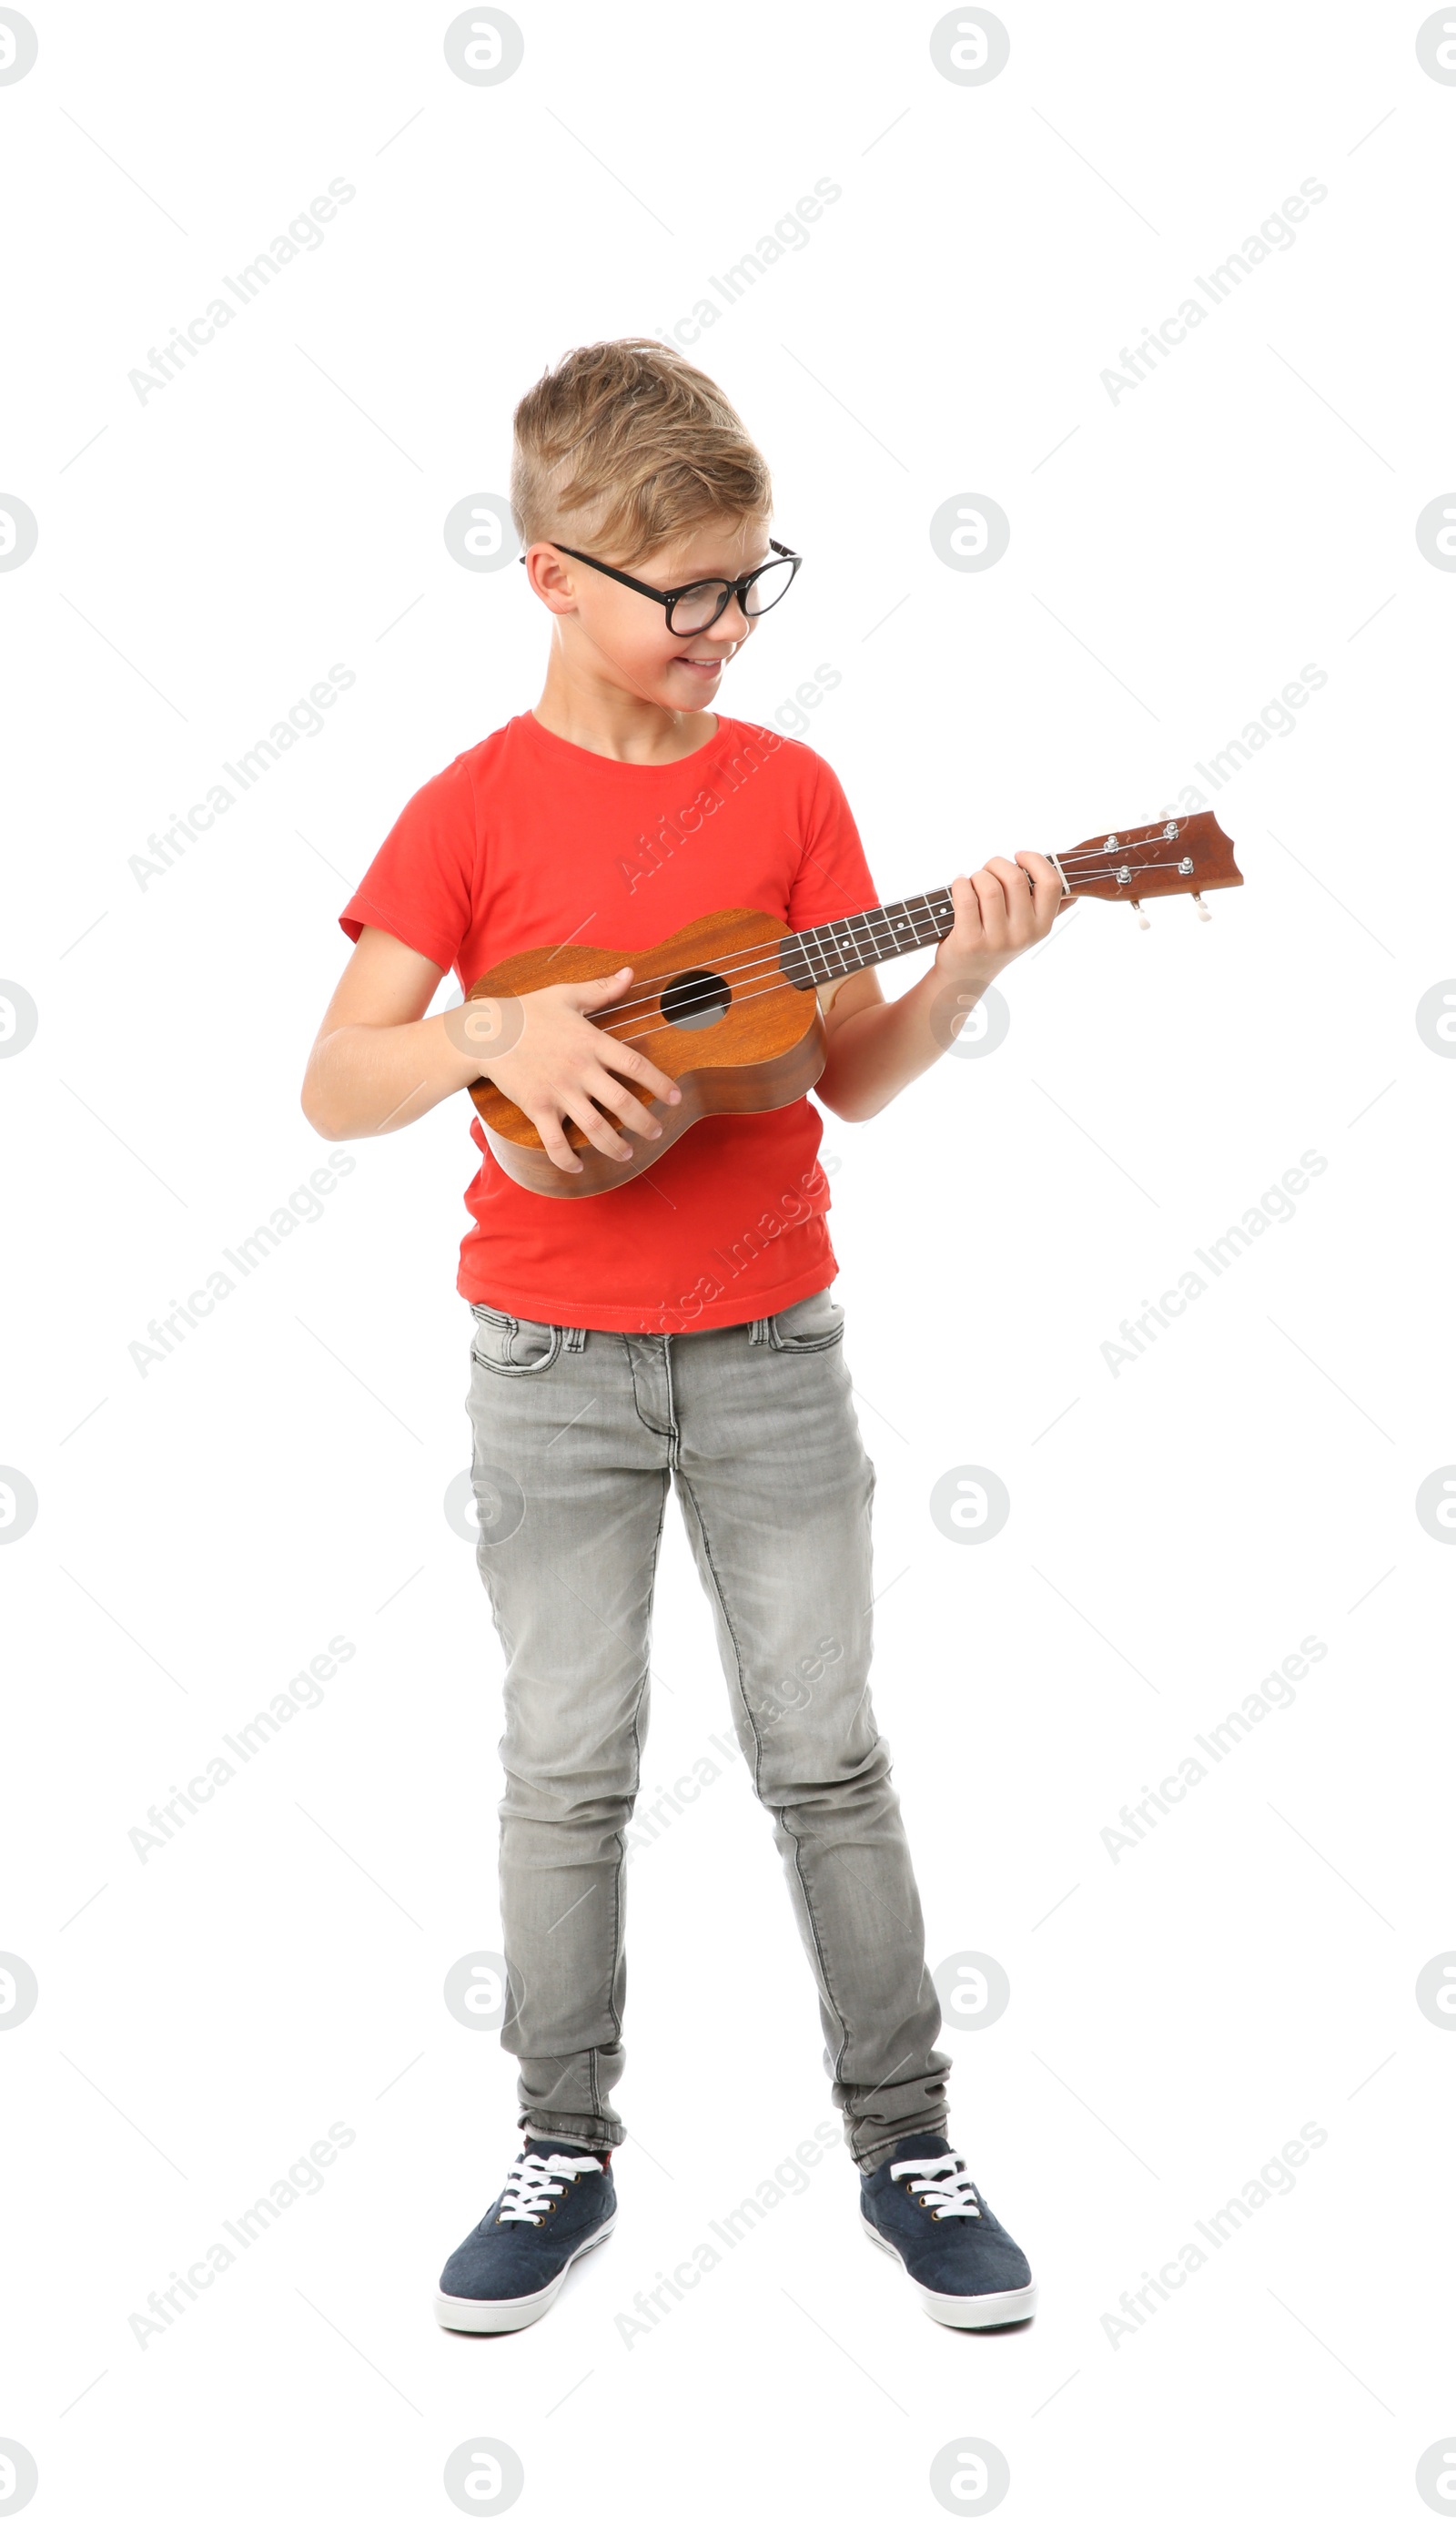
[510,339,773,563]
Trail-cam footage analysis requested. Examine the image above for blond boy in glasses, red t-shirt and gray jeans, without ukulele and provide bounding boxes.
[303,340,1062,2333]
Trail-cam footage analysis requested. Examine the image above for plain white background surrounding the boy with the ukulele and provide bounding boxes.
[0,0,1456,2525]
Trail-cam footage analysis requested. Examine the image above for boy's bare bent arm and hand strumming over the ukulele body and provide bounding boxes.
[300,929,679,1174]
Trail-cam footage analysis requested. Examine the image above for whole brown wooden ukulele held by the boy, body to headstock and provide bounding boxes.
[467,810,1244,1202]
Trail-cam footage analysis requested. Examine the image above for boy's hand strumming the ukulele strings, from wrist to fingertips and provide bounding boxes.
[447,965,682,1174]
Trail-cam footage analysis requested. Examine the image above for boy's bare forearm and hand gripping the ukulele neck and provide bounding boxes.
[815,851,1065,1121]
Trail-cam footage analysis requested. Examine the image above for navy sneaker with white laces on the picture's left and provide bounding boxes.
[434,2139,616,2333]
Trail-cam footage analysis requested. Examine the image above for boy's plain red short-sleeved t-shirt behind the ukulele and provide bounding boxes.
[340,709,878,1333]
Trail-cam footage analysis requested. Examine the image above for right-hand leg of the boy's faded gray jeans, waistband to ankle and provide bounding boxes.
[672,1293,951,2169]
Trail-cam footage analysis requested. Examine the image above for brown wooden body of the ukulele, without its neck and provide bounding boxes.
[467,911,825,1202]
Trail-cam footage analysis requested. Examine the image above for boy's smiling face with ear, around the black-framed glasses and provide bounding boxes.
[528,518,773,712]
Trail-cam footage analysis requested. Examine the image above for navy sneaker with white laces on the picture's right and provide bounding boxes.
[861,2131,1037,2330]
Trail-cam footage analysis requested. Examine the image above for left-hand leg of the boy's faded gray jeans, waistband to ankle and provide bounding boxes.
[470,1311,669,2149]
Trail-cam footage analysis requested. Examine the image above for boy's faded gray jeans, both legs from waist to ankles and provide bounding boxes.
[459,1291,949,2169]
